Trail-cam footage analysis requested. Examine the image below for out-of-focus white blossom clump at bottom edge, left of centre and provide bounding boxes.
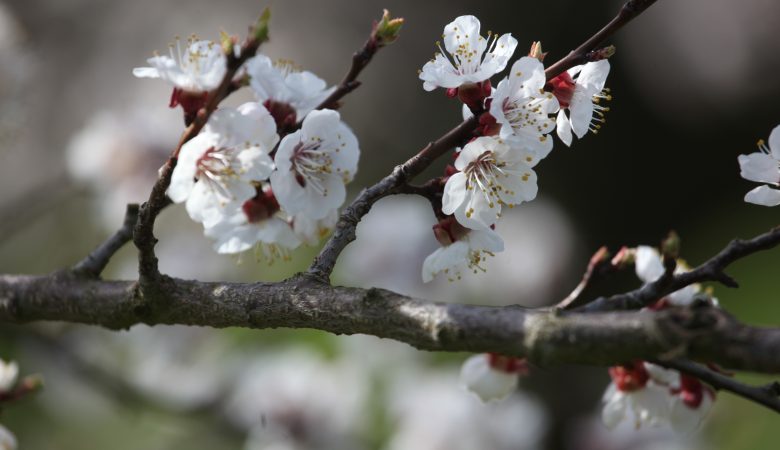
[225,349,369,449]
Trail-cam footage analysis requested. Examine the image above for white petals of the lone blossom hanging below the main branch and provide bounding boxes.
[460,353,519,402]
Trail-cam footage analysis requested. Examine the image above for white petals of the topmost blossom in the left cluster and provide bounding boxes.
[133,41,227,92]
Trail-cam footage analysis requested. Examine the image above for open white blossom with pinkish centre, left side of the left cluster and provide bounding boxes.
[168,103,279,227]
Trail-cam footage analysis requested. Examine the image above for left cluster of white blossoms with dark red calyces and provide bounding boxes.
[133,38,360,260]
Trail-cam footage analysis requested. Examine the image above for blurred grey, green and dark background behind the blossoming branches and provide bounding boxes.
[0,0,780,450]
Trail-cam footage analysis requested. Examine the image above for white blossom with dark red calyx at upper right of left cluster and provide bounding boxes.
[245,55,335,125]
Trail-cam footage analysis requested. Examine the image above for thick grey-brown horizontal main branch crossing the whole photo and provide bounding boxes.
[0,275,780,372]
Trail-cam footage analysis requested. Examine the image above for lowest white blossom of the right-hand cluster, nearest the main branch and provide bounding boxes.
[422,224,504,283]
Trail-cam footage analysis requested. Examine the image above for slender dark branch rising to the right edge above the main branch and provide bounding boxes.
[577,227,780,312]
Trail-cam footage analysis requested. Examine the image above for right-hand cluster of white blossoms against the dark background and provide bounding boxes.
[419,16,610,281]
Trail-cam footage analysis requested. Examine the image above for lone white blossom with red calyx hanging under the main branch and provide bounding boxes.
[460,353,528,402]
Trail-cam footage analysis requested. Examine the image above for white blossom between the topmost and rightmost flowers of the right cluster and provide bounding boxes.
[490,56,558,158]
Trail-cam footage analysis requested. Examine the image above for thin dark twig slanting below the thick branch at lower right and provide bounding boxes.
[652,359,780,413]
